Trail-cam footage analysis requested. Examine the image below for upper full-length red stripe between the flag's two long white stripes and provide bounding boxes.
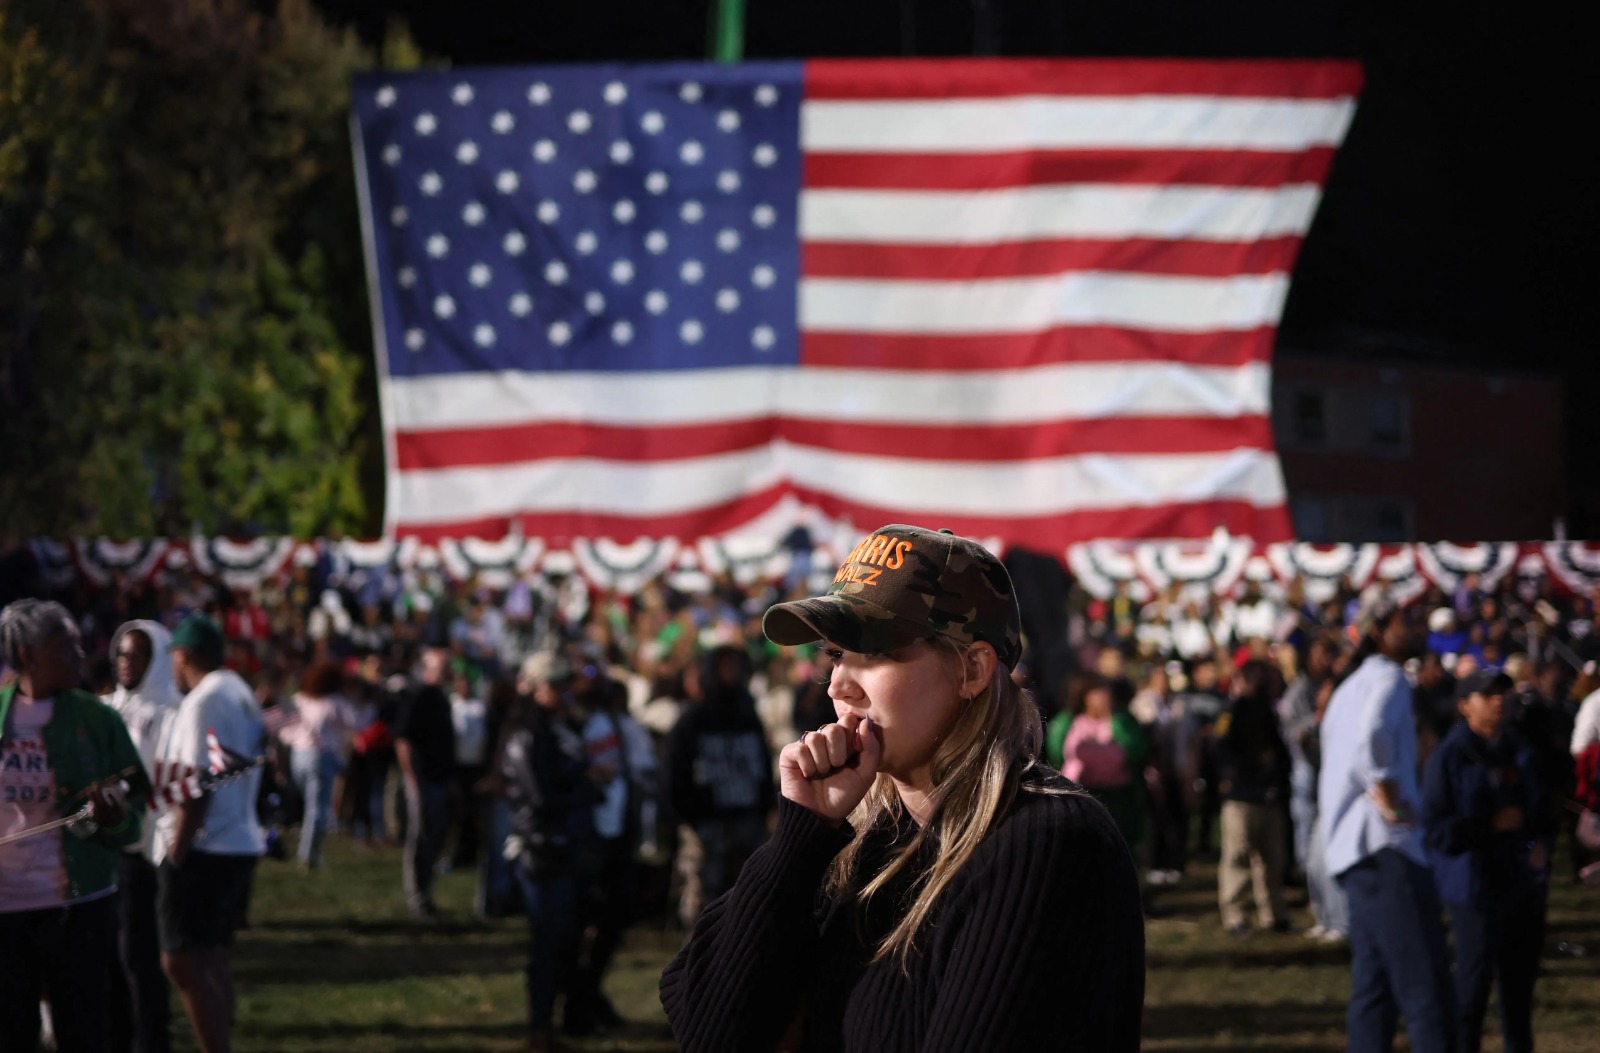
[395,416,1272,470]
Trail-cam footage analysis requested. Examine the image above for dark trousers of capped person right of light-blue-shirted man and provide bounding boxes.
[1450,888,1546,1053]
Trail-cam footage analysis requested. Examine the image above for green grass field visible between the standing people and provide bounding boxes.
[200,839,1600,1053]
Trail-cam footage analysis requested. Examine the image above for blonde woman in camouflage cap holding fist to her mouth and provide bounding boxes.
[661,525,1144,1053]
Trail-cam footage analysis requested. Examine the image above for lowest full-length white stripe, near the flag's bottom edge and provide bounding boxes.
[400,440,1283,525]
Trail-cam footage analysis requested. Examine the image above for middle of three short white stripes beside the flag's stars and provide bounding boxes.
[800,184,1322,245]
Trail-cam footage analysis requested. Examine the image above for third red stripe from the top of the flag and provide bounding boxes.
[800,237,1301,280]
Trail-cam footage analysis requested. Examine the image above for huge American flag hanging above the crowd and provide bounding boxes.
[354,59,1360,552]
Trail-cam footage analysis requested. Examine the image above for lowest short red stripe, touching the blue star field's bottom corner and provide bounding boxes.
[800,325,1275,371]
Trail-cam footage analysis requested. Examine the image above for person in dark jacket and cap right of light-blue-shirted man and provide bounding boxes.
[1422,671,1549,1053]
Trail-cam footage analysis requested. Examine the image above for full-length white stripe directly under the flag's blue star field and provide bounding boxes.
[389,362,1272,428]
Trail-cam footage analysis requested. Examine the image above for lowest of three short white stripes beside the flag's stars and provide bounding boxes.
[800,270,1290,334]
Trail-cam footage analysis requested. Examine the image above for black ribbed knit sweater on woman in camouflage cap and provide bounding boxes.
[661,775,1144,1053]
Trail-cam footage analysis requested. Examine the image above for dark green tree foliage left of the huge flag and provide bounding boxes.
[0,0,414,536]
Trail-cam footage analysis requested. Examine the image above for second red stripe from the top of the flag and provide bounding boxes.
[802,147,1333,190]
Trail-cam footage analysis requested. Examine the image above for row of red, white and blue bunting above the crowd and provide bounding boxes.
[15,525,1600,602]
